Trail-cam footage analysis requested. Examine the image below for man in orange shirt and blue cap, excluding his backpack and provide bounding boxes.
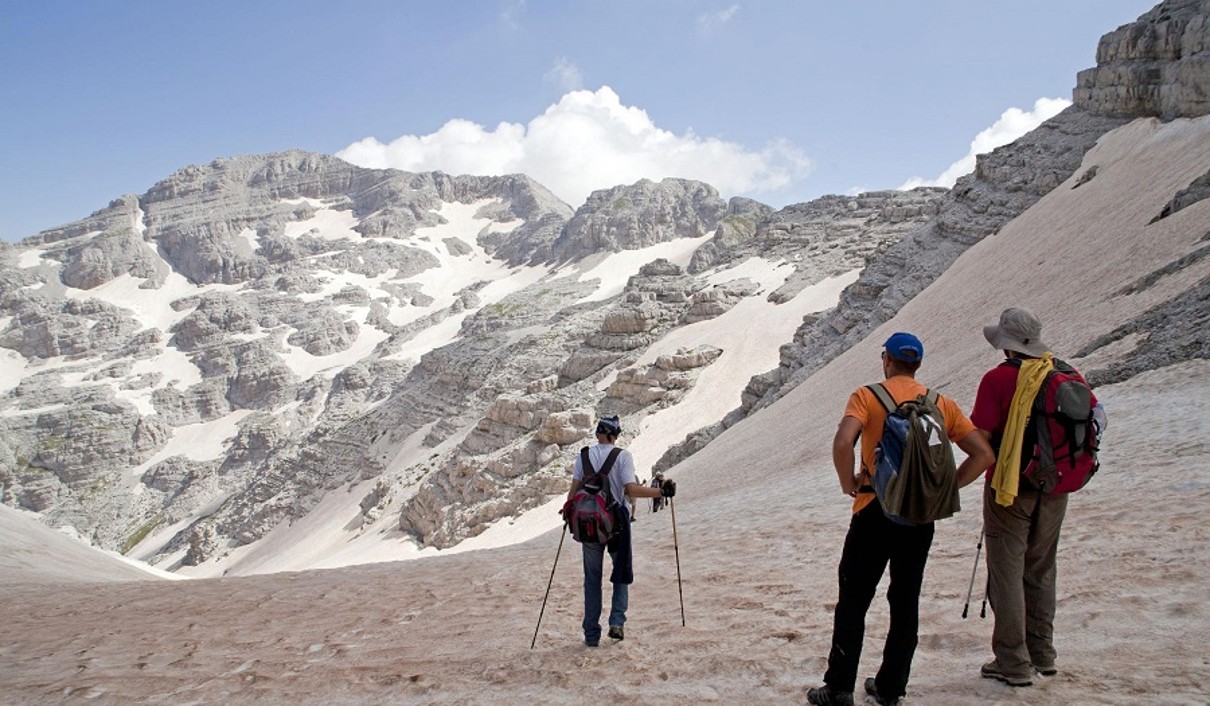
[807,333,995,706]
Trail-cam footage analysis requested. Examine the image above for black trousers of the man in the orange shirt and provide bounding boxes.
[824,500,933,698]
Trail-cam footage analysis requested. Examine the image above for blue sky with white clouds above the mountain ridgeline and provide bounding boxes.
[0,0,1153,241]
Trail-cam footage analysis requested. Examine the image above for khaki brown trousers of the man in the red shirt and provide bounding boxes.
[984,480,1067,678]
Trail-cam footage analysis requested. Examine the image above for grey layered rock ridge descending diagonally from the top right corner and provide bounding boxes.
[656,0,1210,470]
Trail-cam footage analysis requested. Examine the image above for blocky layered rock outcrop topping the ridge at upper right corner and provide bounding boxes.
[1072,0,1210,120]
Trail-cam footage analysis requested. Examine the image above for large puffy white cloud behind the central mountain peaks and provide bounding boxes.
[336,86,811,207]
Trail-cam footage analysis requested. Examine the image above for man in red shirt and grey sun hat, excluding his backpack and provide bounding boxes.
[970,309,1104,687]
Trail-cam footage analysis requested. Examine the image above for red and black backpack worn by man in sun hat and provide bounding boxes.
[1009,358,1100,494]
